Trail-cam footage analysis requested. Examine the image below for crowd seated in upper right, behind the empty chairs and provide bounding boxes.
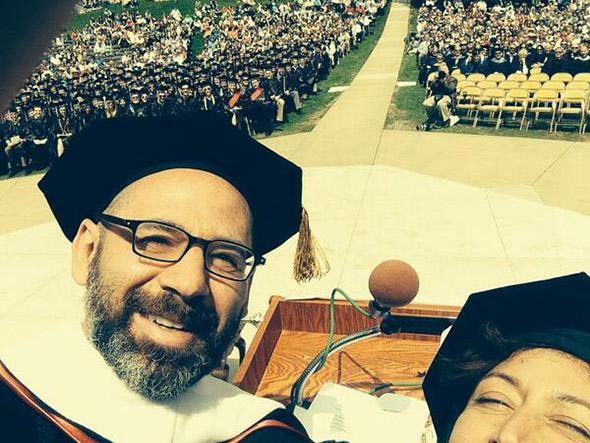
[407,0,590,85]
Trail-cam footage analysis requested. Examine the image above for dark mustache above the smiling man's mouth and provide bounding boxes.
[121,289,219,335]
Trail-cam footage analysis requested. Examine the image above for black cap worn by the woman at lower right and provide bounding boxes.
[423,273,590,442]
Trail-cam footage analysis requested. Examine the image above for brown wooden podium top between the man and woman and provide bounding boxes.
[233,296,461,404]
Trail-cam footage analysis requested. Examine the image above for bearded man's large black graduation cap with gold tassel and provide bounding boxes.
[39,112,329,282]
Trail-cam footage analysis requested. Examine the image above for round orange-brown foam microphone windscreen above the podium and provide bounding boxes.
[369,260,420,308]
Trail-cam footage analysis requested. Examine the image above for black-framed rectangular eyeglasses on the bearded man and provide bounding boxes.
[98,214,266,281]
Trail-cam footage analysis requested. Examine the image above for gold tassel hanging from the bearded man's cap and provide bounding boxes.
[293,208,330,283]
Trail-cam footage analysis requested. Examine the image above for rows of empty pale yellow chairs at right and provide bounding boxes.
[456,86,590,134]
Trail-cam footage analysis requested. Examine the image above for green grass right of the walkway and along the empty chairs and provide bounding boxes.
[385,8,590,141]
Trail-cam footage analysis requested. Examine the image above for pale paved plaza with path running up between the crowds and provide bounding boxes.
[0,4,590,360]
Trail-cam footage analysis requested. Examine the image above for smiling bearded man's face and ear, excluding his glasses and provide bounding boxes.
[74,169,252,401]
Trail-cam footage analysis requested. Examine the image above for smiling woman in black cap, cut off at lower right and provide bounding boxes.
[424,273,590,443]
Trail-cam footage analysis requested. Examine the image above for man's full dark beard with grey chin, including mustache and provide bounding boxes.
[85,251,240,401]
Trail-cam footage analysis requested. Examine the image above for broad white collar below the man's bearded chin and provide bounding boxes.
[0,323,282,443]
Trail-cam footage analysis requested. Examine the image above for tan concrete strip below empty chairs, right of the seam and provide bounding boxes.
[375,130,590,215]
